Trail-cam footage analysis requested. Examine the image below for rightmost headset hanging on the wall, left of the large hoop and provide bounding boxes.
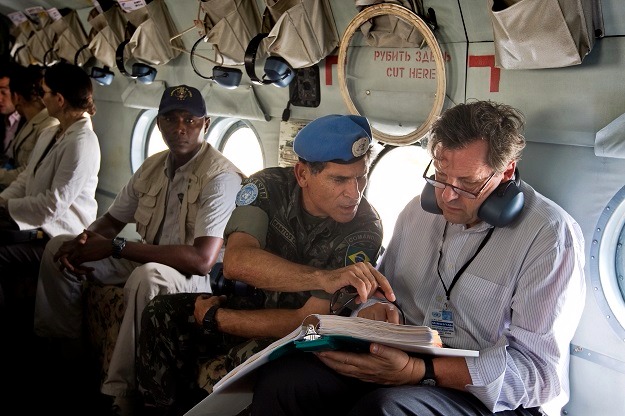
[244,33,295,88]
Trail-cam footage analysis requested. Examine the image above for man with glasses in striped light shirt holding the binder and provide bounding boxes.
[251,101,585,416]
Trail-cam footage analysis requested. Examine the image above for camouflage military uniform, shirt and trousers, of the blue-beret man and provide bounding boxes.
[138,167,382,406]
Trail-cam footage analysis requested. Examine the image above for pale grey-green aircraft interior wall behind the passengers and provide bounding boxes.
[0,0,625,416]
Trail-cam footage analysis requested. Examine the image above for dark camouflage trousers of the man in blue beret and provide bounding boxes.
[136,293,275,408]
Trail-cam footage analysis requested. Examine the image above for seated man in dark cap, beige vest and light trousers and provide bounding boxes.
[35,85,244,413]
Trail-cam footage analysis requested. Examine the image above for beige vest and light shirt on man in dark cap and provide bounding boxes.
[108,143,244,249]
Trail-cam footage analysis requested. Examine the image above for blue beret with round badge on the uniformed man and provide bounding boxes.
[293,114,371,163]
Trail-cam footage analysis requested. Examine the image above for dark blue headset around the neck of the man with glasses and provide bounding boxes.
[421,168,525,227]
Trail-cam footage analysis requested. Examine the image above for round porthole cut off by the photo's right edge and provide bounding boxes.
[590,187,625,341]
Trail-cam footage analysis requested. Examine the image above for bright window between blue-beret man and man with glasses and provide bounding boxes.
[366,145,430,247]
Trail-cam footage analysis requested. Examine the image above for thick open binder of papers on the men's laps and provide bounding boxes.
[185,314,479,416]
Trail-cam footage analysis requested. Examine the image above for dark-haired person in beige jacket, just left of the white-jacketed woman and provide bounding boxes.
[0,65,59,189]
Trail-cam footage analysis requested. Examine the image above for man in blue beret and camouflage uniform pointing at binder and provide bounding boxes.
[137,115,395,414]
